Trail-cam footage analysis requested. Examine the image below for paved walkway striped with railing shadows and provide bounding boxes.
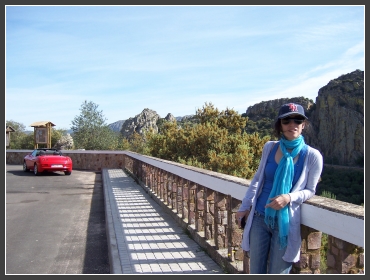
[102,169,225,274]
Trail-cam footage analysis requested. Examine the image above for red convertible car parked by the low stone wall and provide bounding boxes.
[23,148,72,175]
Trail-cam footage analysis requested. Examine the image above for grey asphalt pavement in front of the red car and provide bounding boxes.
[5,165,110,274]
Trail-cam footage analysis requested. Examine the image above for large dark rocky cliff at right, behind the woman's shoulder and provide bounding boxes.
[310,70,365,165]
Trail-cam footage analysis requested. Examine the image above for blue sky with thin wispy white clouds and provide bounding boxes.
[5,5,365,130]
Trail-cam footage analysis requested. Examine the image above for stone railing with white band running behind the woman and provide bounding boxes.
[6,150,365,274]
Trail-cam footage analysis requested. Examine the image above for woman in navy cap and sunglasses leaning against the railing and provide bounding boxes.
[236,103,323,274]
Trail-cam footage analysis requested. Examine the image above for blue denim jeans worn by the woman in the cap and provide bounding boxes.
[249,211,292,274]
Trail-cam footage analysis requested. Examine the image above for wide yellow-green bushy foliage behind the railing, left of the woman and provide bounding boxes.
[145,103,269,178]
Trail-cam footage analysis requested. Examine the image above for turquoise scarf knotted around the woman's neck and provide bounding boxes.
[265,135,305,249]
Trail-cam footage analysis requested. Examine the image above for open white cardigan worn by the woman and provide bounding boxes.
[238,141,323,262]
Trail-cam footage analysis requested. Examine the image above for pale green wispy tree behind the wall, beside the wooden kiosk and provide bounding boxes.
[71,100,120,150]
